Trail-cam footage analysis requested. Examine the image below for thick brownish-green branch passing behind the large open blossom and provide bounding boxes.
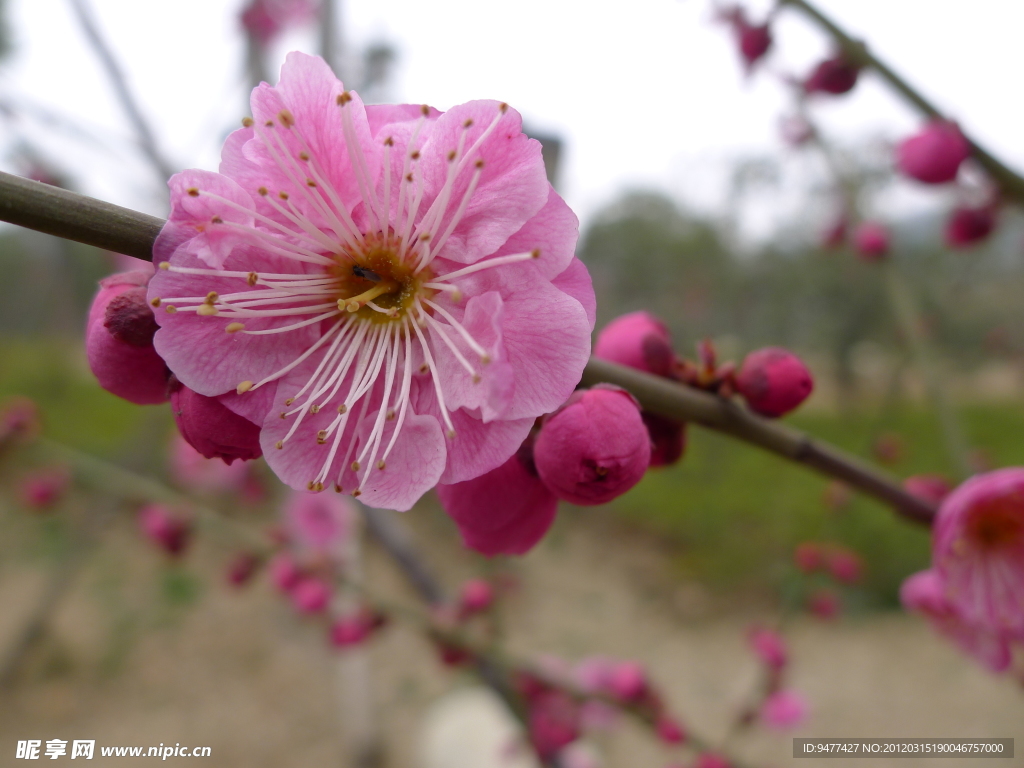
[0,173,935,523]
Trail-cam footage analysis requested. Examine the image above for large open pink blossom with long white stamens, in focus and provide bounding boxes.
[150,53,594,510]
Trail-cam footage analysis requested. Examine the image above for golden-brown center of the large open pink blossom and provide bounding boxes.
[328,233,436,324]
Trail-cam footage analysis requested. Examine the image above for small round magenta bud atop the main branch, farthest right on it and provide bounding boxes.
[736,347,814,419]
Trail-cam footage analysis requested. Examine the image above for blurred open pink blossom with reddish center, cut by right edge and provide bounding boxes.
[932,467,1024,639]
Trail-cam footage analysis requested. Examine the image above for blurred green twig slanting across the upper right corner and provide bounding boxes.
[778,0,1024,205]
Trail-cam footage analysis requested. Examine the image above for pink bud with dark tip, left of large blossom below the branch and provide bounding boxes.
[85,269,170,406]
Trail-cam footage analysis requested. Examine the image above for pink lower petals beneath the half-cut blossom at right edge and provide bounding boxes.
[899,569,1011,672]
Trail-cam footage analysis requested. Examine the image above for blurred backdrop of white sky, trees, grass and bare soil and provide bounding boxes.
[0,0,1024,768]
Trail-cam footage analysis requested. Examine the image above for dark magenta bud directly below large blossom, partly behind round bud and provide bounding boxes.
[437,437,558,557]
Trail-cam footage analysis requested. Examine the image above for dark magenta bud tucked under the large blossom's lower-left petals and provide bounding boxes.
[171,384,263,464]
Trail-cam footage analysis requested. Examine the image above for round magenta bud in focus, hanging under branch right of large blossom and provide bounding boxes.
[534,385,650,505]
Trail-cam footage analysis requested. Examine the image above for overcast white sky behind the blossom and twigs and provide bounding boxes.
[0,0,1024,237]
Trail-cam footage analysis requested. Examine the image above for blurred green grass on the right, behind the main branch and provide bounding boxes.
[614,403,1024,605]
